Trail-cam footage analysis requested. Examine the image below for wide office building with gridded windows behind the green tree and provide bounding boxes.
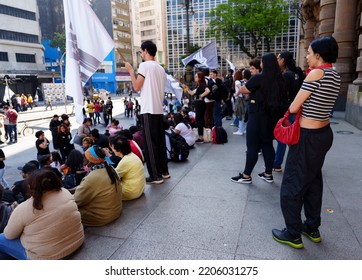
[167,0,299,78]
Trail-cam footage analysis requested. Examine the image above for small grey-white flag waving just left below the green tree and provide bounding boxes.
[182,41,219,69]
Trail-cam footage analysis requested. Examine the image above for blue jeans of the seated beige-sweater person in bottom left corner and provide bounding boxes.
[0,233,28,260]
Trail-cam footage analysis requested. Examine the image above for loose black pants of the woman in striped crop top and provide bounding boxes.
[280,125,333,236]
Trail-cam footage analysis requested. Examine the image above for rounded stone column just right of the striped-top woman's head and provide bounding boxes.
[333,0,357,110]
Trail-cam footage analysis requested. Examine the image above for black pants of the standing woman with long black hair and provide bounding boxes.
[243,112,275,176]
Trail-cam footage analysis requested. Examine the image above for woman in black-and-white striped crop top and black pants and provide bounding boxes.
[272,36,341,249]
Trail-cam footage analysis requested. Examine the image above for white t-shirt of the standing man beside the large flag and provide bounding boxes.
[138,60,166,115]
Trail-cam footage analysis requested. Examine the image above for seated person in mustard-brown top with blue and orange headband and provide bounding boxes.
[74,146,122,226]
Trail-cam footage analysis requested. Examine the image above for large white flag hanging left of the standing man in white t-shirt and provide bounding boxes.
[63,0,114,123]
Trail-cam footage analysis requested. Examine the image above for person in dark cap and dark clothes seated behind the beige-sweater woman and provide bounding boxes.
[3,162,38,203]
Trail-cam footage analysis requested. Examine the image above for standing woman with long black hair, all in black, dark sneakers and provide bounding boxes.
[231,53,287,184]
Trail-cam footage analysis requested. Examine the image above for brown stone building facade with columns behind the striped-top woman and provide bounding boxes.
[300,0,362,129]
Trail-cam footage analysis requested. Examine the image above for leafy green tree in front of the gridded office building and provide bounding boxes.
[208,0,289,58]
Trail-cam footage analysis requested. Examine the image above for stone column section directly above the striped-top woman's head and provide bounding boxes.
[319,0,337,37]
